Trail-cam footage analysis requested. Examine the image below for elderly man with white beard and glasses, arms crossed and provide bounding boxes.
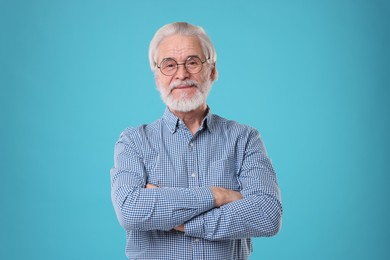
[111,22,282,260]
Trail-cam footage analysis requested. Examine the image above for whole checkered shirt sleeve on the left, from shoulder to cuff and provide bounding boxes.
[111,130,214,231]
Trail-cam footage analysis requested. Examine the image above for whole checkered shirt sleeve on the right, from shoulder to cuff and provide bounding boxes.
[185,130,282,240]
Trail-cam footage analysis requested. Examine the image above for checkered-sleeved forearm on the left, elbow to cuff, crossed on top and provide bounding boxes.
[112,172,214,230]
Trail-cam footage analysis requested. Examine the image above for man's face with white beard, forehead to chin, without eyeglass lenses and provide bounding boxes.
[155,35,215,112]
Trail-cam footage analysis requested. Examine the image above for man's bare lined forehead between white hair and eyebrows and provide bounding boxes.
[157,35,204,61]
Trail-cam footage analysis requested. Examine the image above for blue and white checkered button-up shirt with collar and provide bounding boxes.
[111,109,282,260]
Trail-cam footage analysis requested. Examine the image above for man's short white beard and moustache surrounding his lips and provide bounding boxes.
[159,79,212,112]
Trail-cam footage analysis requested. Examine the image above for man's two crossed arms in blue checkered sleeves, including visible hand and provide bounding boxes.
[111,129,282,240]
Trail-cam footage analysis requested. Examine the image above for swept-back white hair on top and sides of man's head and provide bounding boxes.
[149,22,217,79]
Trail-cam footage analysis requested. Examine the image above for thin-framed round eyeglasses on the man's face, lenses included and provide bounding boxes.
[157,56,210,76]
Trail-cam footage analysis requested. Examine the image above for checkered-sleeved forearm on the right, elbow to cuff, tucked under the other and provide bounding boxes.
[184,192,282,240]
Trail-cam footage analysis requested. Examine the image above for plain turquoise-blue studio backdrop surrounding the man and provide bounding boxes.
[0,0,390,260]
